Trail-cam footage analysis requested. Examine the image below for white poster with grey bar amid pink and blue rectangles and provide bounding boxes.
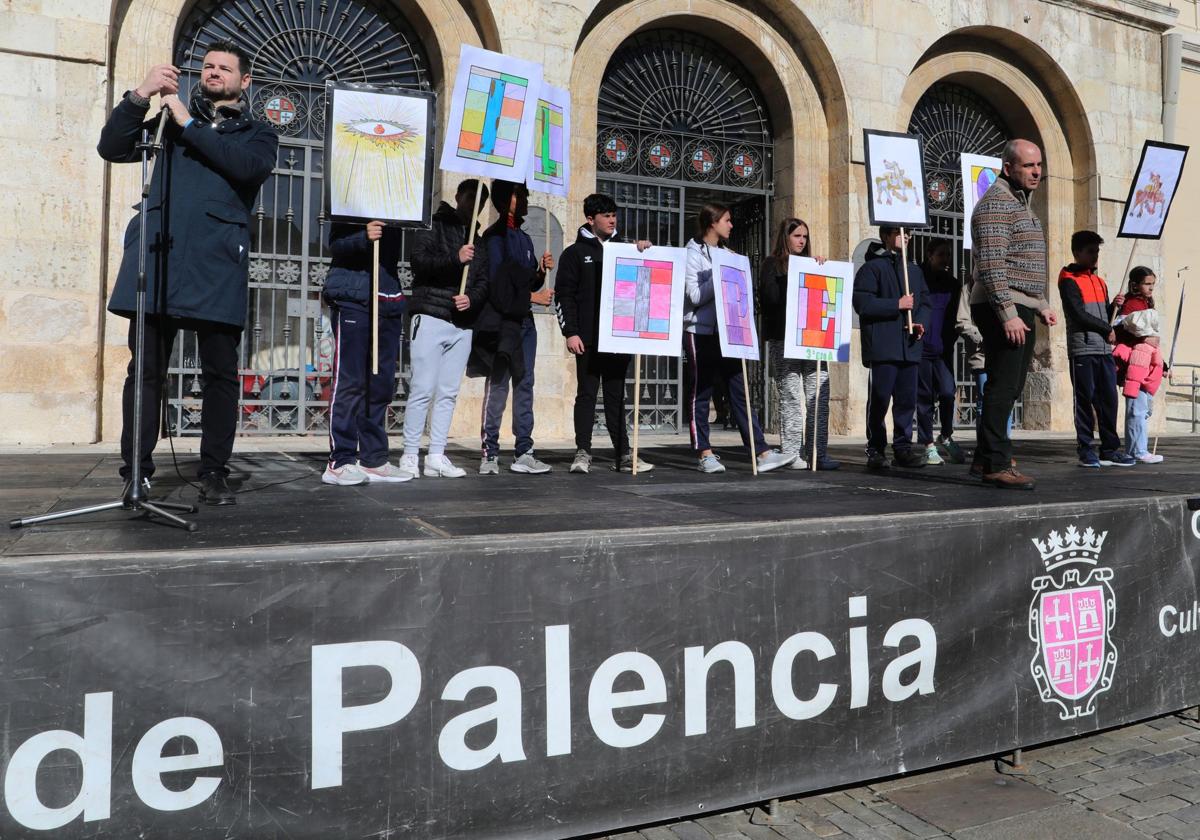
[598,244,688,356]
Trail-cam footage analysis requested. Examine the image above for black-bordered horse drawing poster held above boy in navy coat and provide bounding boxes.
[863,128,929,228]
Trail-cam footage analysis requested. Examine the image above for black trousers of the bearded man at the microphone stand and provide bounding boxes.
[121,316,241,479]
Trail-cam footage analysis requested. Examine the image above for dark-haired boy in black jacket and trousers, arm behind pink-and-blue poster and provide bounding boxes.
[554,193,654,473]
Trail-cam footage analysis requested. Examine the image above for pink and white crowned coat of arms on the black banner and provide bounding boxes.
[1030,526,1117,720]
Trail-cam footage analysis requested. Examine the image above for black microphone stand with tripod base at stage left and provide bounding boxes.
[8,108,197,532]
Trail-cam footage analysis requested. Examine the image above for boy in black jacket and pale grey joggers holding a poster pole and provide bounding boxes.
[400,178,487,479]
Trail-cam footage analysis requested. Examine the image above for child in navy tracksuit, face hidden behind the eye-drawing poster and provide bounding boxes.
[320,222,413,485]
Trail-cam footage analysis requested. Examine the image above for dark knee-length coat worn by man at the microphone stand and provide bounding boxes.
[96,93,280,326]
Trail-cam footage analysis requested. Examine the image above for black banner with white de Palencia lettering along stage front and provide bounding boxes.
[0,499,1200,840]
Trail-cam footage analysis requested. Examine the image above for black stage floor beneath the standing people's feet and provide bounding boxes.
[7,438,1200,557]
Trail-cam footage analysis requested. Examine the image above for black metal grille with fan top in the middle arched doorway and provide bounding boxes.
[596,30,773,433]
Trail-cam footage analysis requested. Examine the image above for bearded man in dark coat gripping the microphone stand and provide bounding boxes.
[97,41,278,504]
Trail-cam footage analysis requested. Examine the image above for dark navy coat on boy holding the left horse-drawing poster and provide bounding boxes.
[853,251,929,367]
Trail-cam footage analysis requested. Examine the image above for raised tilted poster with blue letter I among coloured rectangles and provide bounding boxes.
[439,46,541,181]
